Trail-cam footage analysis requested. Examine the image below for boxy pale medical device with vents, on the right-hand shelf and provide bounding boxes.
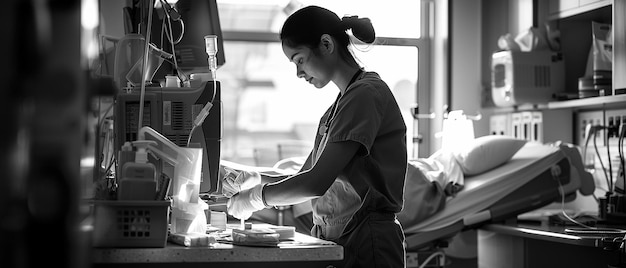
[491,51,564,107]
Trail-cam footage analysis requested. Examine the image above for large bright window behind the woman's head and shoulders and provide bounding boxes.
[217,0,425,166]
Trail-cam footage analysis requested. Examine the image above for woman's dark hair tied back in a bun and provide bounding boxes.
[280,6,376,58]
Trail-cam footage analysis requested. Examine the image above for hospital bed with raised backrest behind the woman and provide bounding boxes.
[399,143,595,250]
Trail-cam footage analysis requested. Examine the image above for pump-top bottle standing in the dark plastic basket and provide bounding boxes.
[118,141,157,200]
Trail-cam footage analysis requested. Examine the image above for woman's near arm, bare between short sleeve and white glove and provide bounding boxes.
[264,141,360,206]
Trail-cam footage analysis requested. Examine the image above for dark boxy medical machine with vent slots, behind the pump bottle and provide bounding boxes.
[114,81,222,193]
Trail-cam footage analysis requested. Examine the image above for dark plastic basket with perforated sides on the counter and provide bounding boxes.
[93,200,171,248]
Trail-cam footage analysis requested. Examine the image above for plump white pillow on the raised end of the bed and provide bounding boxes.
[453,135,526,175]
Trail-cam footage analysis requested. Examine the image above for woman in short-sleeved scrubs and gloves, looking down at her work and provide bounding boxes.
[228,6,407,267]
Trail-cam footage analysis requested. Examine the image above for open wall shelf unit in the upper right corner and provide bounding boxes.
[546,0,626,110]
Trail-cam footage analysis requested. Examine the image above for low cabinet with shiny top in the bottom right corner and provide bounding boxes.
[478,220,624,268]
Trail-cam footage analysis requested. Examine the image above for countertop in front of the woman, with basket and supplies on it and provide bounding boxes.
[92,225,343,267]
